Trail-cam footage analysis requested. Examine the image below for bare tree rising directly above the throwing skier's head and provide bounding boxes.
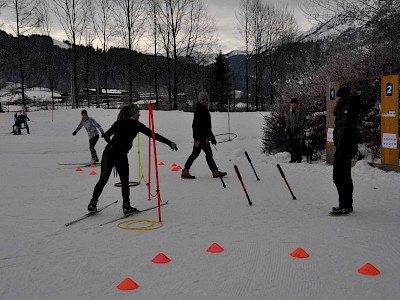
[115,0,146,103]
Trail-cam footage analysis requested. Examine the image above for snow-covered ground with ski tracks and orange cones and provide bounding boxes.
[0,109,400,300]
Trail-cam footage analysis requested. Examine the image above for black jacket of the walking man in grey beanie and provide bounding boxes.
[192,102,214,141]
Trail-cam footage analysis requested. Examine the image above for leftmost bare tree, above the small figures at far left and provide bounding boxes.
[3,0,41,106]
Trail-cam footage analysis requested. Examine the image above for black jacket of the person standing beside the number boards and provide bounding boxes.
[333,95,361,158]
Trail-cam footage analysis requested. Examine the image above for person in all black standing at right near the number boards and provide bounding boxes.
[330,87,361,216]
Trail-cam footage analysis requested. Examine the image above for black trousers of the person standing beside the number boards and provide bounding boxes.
[333,154,353,208]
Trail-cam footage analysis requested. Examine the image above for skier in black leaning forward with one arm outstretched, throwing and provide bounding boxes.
[88,104,178,214]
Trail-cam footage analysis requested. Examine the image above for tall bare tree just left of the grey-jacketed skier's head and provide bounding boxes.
[53,0,89,108]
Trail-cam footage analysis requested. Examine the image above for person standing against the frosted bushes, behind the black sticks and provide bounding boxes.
[285,98,306,163]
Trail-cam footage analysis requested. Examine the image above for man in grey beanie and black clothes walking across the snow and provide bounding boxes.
[181,92,227,179]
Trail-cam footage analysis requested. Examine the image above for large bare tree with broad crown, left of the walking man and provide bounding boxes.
[156,0,215,109]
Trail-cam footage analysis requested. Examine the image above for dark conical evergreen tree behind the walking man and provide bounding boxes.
[208,51,232,110]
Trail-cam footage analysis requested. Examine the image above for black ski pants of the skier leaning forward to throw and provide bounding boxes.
[92,146,130,205]
